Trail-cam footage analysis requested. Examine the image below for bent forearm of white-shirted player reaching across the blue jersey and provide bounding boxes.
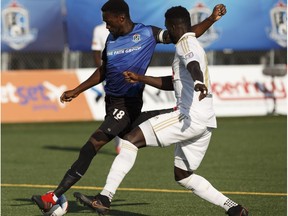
[123,71,174,91]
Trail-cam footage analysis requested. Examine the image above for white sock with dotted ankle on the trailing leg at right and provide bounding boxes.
[178,174,237,211]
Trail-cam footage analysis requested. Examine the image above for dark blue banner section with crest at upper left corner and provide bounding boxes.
[1,0,65,52]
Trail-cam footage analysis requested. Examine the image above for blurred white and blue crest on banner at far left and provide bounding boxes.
[2,0,37,50]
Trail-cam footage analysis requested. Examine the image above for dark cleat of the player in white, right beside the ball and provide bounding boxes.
[73,192,111,215]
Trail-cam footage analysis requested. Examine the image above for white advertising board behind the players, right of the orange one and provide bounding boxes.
[77,65,287,120]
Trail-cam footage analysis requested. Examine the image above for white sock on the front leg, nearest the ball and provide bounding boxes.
[100,140,138,201]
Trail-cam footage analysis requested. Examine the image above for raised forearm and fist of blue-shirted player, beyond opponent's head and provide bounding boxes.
[191,4,227,37]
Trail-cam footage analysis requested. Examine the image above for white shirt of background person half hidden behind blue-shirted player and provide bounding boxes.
[91,23,109,51]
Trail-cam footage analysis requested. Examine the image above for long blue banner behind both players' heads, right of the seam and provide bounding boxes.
[66,0,287,51]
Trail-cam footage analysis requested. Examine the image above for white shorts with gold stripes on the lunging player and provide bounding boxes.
[139,110,212,171]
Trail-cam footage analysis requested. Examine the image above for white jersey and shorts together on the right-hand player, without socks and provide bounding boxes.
[139,33,217,171]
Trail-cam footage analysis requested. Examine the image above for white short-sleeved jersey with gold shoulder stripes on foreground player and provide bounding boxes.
[172,32,217,128]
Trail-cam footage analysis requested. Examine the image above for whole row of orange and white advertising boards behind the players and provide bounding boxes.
[1,65,287,123]
